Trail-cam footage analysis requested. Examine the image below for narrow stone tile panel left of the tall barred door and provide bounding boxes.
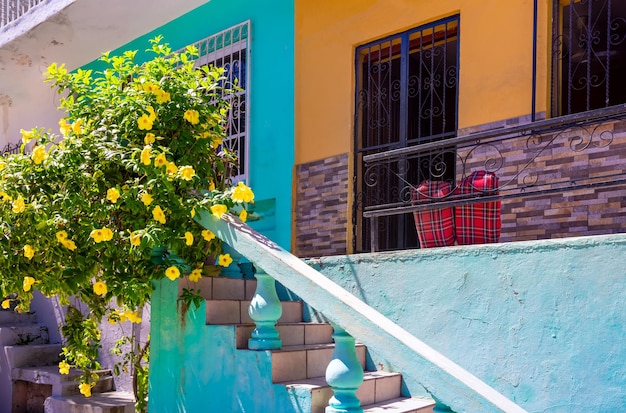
[294,154,348,257]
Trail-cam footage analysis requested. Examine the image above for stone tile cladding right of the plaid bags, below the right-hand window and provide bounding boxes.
[457,115,626,242]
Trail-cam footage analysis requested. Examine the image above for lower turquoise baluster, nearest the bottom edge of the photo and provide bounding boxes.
[326,325,363,413]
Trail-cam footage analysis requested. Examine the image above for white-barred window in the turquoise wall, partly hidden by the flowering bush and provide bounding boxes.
[194,21,250,182]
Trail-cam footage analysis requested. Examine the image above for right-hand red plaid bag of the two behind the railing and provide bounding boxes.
[454,171,501,245]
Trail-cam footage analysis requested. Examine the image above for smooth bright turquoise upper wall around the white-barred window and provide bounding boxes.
[81,0,295,250]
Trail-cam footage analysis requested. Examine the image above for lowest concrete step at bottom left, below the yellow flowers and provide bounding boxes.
[44,392,135,413]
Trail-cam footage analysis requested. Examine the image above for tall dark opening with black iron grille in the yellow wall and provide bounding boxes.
[353,16,459,252]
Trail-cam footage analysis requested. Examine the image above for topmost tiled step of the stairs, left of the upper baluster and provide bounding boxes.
[178,277,257,301]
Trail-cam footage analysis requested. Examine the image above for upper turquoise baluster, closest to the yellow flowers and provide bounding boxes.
[248,268,283,350]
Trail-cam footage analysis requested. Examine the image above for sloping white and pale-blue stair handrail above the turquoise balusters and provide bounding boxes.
[198,211,525,413]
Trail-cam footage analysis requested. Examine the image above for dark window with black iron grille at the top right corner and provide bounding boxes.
[552,0,626,116]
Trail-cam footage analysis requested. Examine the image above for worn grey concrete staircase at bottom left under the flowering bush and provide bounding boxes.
[0,310,134,413]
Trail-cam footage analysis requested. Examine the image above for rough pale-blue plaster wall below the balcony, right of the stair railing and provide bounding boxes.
[308,234,626,413]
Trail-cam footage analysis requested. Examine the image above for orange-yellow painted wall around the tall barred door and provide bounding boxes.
[295,0,549,164]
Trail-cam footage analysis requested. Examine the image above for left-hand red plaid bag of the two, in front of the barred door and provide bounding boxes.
[413,180,454,248]
